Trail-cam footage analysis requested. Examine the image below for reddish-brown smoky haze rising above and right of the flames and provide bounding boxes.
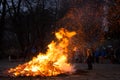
[57,1,104,51]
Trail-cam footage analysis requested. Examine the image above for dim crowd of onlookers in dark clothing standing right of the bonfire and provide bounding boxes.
[75,47,120,64]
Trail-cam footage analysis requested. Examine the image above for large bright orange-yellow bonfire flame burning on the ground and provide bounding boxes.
[8,28,76,76]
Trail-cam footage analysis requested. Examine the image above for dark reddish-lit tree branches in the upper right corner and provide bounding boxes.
[107,0,120,40]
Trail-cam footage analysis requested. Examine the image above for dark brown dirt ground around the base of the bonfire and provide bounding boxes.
[0,60,120,80]
